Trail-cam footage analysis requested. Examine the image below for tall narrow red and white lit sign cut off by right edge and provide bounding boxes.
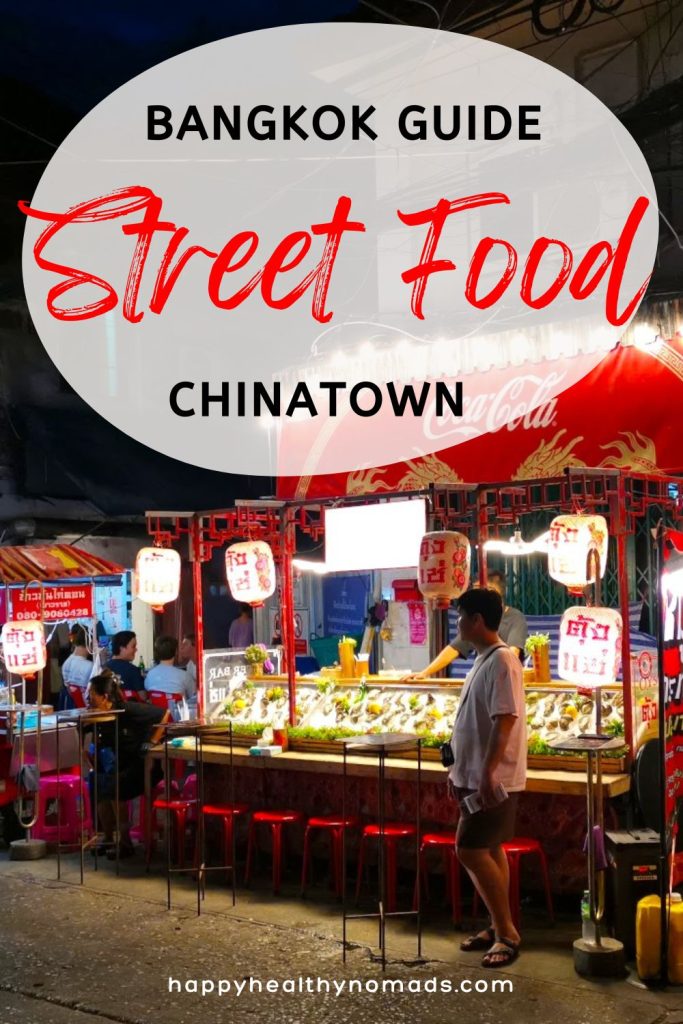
[661,530,683,835]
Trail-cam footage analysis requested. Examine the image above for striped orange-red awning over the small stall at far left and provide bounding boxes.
[0,544,126,585]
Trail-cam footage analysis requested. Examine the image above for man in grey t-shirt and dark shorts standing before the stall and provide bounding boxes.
[449,588,526,968]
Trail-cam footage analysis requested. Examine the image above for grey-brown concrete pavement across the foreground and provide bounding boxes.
[0,853,683,1024]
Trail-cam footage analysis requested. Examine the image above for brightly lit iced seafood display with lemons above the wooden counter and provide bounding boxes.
[200,655,624,766]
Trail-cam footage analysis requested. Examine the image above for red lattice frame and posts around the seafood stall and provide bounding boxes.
[147,468,683,746]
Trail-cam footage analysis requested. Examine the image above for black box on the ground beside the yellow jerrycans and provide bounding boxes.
[605,828,659,956]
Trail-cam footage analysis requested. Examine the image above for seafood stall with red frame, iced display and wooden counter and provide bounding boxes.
[143,469,679,889]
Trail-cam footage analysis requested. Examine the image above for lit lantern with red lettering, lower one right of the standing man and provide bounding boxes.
[557,607,622,686]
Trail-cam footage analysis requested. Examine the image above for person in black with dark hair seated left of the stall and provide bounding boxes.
[88,669,170,857]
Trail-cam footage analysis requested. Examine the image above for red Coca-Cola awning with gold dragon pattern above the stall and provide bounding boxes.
[279,336,683,498]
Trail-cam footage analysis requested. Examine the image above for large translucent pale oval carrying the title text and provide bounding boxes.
[24,24,657,475]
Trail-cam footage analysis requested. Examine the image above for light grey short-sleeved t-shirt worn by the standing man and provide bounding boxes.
[449,646,526,793]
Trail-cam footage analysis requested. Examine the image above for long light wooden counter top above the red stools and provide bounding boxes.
[147,743,631,797]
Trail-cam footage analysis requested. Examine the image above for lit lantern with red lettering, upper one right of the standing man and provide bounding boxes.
[548,515,608,590]
